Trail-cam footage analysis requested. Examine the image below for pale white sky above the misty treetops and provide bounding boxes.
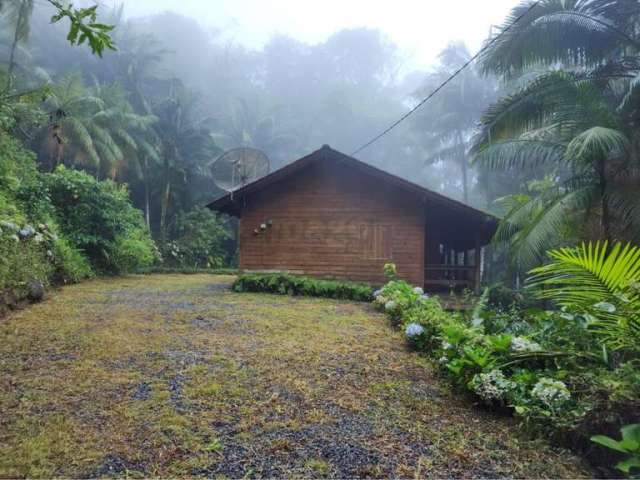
[124,0,518,68]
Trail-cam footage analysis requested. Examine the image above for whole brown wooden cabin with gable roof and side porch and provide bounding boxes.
[208,145,497,291]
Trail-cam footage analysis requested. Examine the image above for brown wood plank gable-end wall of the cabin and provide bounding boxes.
[239,160,425,285]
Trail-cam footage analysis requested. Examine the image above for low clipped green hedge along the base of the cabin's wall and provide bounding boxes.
[233,273,373,302]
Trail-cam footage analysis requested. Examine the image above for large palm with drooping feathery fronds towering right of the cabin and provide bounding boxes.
[474,0,640,268]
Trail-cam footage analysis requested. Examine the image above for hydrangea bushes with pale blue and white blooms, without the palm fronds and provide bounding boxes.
[373,266,640,472]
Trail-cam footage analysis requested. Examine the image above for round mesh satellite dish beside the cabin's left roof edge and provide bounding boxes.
[211,147,270,192]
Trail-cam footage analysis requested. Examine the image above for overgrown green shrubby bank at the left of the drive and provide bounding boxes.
[0,130,157,312]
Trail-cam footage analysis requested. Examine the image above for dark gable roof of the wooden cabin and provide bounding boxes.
[207,145,498,223]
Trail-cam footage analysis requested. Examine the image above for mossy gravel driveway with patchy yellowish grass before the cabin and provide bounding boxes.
[0,275,589,478]
